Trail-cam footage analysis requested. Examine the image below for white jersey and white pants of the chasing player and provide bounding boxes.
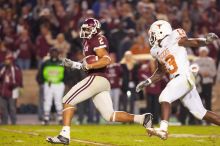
[151,29,207,119]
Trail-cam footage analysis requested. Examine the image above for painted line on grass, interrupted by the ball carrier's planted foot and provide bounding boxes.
[0,128,116,146]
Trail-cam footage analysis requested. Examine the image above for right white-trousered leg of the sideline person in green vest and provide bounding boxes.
[53,83,65,124]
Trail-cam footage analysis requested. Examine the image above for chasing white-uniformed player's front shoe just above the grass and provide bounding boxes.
[147,128,168,140]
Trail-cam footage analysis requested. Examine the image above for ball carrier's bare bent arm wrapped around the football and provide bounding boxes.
[86,48,111,70]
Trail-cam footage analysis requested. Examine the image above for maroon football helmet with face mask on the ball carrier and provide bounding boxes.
[80,18,101,39]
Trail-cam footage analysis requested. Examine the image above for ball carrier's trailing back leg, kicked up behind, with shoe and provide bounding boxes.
[93,91,152,127]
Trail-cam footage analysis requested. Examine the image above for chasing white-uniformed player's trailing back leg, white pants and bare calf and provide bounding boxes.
[182,87,220,126]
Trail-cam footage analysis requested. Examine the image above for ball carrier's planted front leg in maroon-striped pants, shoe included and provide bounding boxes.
[47,76,111,144]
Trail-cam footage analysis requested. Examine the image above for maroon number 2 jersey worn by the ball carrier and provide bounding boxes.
[83,33,109,77]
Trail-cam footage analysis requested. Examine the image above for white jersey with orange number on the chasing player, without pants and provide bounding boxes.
[150,29,192,84]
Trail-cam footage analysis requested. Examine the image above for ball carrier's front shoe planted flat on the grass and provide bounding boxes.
[46,135,70,145]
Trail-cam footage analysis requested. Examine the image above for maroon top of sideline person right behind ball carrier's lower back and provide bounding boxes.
[107,63,122,89]
